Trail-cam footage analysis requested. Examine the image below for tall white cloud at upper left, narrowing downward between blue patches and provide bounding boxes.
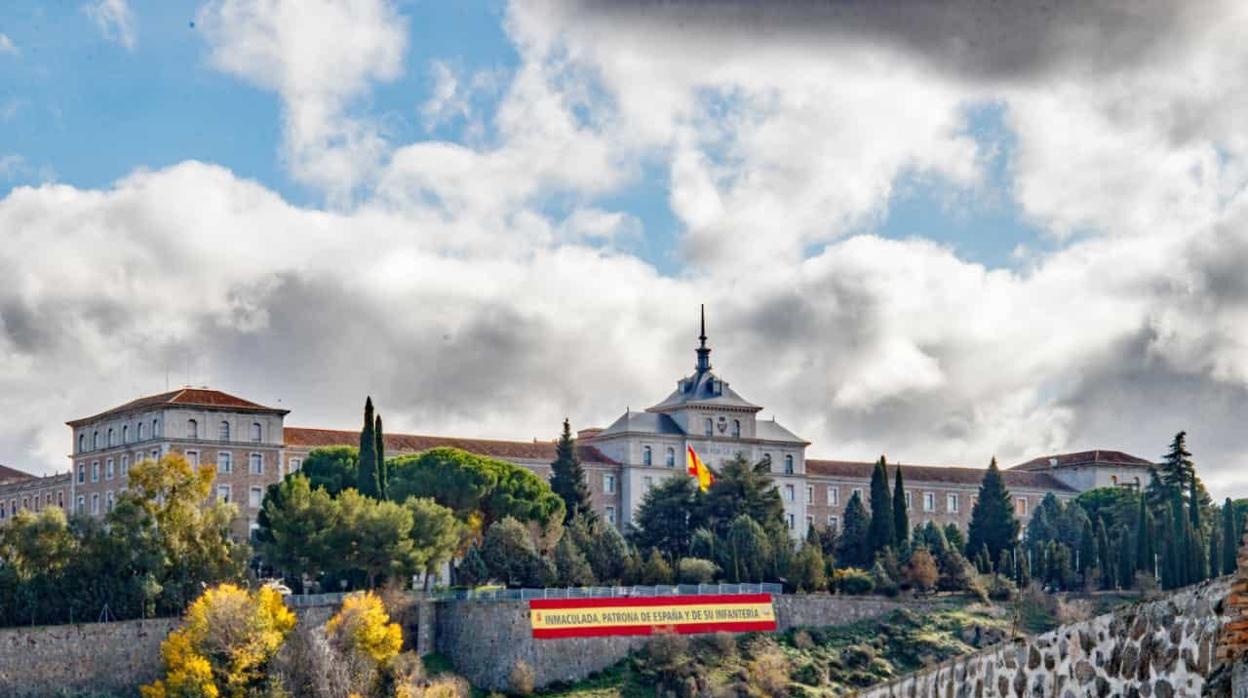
[198,0,407,201]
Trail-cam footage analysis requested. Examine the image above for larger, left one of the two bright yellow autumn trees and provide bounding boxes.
[140,584,295,698]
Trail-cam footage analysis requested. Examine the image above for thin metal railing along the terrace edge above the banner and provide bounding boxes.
[286,583,784,607]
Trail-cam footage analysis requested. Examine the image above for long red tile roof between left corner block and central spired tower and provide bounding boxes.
[285,427,619,466]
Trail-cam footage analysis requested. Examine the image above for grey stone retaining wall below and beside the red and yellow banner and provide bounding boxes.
[436,594,902,691]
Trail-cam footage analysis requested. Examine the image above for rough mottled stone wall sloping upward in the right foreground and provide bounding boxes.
[856,578,1229,698]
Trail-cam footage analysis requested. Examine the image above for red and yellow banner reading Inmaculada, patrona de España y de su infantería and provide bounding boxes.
[529,594,776,639]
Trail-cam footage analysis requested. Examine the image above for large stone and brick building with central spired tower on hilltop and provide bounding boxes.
[0,317,1151,536]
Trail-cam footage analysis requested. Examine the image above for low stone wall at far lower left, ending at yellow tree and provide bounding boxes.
[0,618,180,697]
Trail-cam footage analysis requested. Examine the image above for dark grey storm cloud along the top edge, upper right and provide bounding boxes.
[569,0,1219,80]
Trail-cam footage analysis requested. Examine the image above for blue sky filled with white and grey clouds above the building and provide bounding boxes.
[0,0,1248,497]
